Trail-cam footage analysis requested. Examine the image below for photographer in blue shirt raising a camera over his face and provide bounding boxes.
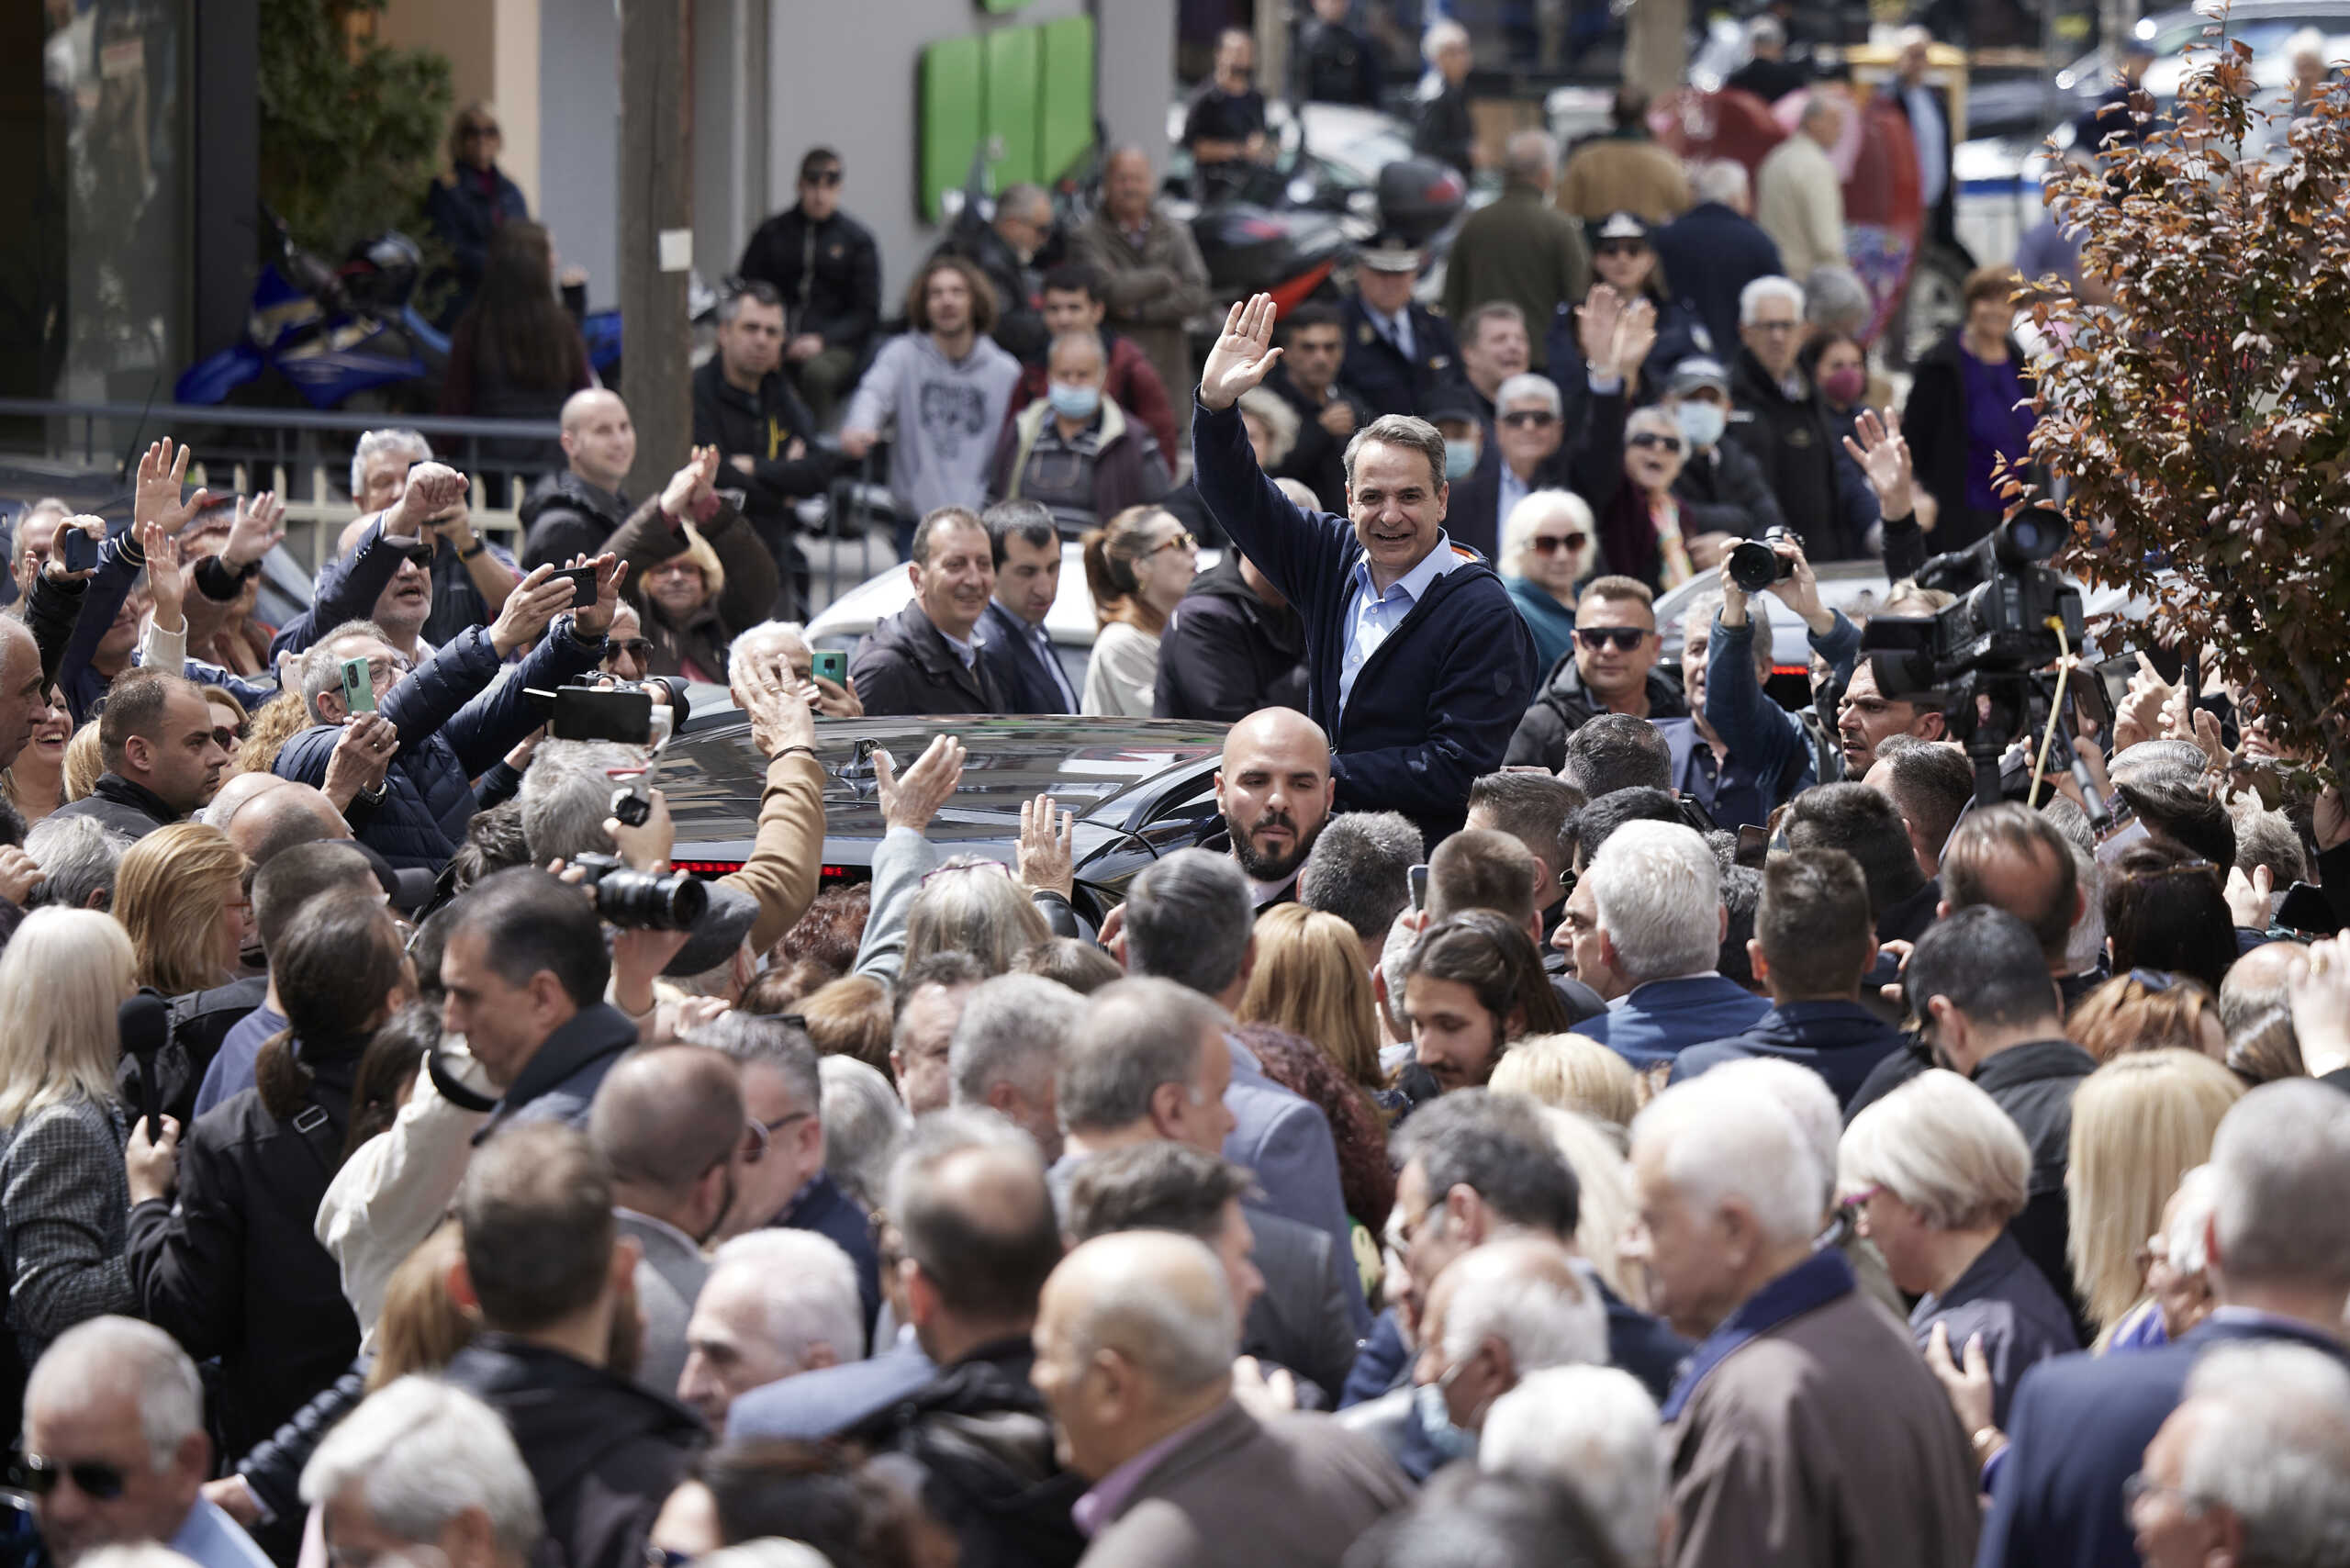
[1666,533,1866,827]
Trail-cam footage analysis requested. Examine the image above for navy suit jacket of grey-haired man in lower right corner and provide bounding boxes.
[1974,1309,2345,1568]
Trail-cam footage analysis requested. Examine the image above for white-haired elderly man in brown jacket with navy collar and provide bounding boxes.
[1621,1081,1981,1568]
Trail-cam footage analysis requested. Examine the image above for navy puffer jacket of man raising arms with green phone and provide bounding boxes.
[273,613,604,872]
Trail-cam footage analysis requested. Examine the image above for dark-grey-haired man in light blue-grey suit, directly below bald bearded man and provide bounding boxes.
[1118,848,1370,1326]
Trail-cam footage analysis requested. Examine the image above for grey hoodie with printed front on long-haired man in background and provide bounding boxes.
[841,331,1020,517]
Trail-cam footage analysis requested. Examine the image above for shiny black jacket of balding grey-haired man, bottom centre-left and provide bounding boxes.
[846,1335,1086,1568]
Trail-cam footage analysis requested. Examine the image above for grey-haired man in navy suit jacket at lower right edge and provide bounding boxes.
[1976,1081,2350,1568]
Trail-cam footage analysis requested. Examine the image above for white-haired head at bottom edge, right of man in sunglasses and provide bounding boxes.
[301,1375,545,1568]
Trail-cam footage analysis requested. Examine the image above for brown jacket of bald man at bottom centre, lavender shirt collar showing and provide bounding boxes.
[1083,1401,1413,1568]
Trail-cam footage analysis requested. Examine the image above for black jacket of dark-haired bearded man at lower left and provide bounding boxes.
[442,1333,710,1568]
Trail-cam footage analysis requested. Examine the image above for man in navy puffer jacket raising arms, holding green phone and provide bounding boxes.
[273,552,625,872]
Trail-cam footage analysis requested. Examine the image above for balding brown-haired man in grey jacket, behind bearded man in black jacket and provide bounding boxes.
[588,1047,745,1396]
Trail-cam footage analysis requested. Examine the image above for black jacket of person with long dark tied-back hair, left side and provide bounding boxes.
[125,1036,366,1453]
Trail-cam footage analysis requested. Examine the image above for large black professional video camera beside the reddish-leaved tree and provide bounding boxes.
[1862,506,2082,806]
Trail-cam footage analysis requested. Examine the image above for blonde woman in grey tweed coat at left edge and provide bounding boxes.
[0,910,139,1366]
